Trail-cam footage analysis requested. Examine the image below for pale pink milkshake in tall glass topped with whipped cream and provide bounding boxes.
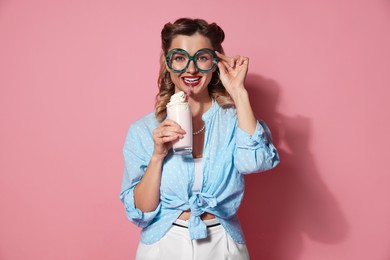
[167,91,192,154]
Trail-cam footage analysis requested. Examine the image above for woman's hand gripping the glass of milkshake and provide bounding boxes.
[153,119,186,159]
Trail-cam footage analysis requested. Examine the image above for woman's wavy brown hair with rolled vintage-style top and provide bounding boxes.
[155,18,234,122]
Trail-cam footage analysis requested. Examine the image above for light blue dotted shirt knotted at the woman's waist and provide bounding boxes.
[120,101,279,244]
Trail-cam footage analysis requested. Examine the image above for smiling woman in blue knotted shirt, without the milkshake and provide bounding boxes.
[120,18,279,260]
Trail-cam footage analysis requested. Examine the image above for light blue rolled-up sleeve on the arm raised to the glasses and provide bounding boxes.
[234,121,280,174]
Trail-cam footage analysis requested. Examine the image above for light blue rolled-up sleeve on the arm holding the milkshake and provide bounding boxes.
[119,124,161,227]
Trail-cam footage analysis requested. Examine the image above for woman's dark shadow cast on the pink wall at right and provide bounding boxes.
[239,74,348,260]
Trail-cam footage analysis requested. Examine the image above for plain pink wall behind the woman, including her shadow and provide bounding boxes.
[0,0,390,260]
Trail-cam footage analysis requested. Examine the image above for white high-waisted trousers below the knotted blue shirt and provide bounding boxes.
[135,219,249,260]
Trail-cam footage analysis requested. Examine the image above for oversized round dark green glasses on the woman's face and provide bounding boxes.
[165,48,218,73]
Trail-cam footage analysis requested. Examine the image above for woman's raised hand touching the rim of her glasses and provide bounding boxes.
[216,52,249,99]
